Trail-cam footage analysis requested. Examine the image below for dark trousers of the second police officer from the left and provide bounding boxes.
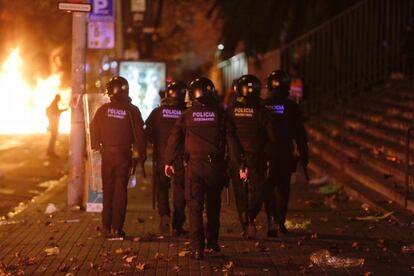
[154,158,185,229]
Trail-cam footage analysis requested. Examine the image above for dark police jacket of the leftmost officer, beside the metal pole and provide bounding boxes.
[90,96,146,155]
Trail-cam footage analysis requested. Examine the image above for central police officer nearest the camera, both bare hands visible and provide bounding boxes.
[165,78,247,260]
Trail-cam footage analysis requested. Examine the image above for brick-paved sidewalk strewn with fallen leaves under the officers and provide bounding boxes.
[0,167,414,275]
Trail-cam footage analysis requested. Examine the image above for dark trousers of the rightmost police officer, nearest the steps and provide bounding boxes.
[265,161,292,225]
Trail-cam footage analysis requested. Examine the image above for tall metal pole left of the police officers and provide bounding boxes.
[67,12,87,207]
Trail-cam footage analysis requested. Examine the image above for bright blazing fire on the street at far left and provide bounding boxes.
[0,49,70,134]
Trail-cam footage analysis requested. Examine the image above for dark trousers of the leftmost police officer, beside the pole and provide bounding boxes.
[102,147,131,230]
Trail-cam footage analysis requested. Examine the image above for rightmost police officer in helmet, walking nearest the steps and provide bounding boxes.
[264,70,308,236]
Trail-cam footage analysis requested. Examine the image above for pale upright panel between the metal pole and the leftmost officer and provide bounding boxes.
[83,93,109,212]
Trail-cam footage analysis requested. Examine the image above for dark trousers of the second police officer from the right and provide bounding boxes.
[231,153,265,223]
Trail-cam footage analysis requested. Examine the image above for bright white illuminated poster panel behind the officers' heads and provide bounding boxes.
[119,61,166,121]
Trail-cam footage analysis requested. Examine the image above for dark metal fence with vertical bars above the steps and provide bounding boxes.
[280,0,414,113]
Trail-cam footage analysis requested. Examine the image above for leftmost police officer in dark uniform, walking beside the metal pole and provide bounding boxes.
[90,76,146,238]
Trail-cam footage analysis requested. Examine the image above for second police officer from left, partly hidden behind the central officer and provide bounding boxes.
[145,81,187,236]
